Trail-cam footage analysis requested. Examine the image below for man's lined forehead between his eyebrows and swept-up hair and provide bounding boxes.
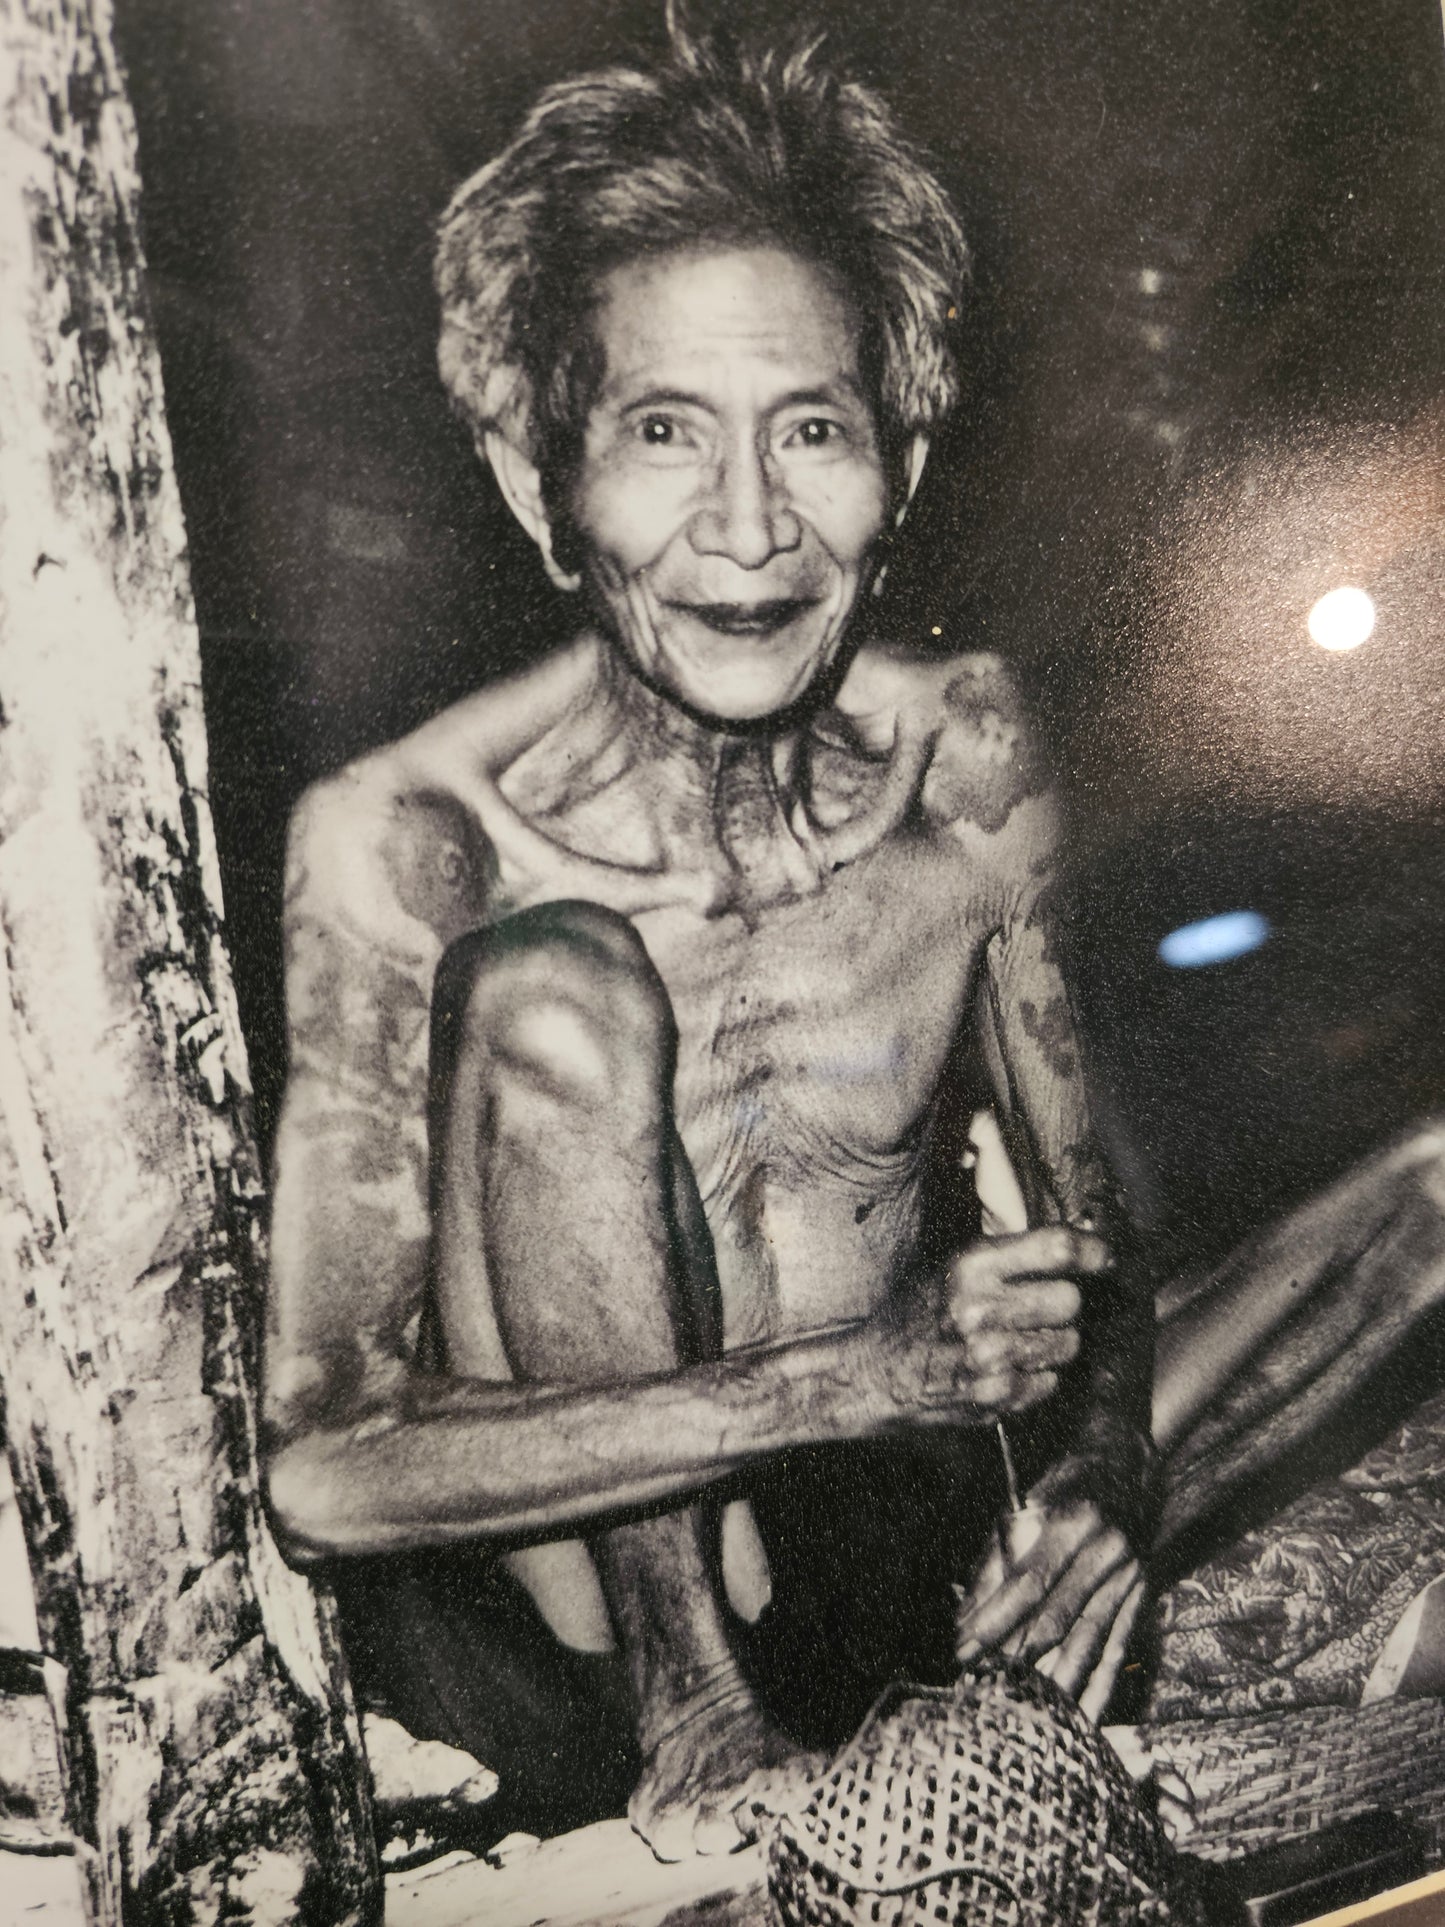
[591,243,875,407]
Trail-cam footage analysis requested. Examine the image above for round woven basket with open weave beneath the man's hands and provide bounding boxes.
[769,1669,1171,1927]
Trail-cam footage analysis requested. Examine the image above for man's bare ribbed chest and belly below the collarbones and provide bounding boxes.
[638,832,983,1343]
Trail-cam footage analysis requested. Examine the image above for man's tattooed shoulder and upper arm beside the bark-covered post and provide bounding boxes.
[268,759,489,1438]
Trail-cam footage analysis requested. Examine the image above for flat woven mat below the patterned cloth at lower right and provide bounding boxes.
[1141,1700,1445,1867]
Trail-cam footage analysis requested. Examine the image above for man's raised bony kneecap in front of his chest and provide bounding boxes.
[435,902,676,1108]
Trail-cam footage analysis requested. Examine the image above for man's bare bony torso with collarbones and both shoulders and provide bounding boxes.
[285,624,1075,1376]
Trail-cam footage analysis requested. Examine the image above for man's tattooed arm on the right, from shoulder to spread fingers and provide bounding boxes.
[948,659,1156,1711]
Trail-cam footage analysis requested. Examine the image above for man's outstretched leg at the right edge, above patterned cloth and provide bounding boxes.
[1154,1122,1445,1549]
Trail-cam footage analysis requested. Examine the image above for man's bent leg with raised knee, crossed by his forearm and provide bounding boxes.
[432,904,816,1854]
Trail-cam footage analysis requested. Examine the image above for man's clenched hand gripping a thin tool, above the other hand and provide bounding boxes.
[850,1226,1112,1432]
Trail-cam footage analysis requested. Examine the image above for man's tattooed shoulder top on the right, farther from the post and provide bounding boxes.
[838,649,1056,854]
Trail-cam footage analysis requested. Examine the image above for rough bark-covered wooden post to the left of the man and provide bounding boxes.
[0,0,378,1927]
